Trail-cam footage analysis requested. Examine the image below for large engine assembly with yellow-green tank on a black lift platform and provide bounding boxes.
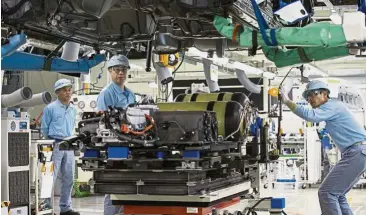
[60,93,277,204]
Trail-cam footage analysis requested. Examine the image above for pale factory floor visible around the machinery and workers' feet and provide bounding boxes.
[55,185,366,215]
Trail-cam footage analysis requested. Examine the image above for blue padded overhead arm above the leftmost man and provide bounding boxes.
[1,34,105,74]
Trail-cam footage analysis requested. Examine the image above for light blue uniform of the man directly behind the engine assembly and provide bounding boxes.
[97,82,136,215]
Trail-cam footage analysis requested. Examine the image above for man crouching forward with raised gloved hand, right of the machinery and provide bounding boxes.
[281,80,366,215]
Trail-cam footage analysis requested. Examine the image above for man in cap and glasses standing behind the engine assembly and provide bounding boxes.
[97,55,136,215]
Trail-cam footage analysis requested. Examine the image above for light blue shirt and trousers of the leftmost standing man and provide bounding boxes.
[41,100,76,213]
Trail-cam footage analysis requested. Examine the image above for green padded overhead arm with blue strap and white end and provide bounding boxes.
[213,1,366,67]
